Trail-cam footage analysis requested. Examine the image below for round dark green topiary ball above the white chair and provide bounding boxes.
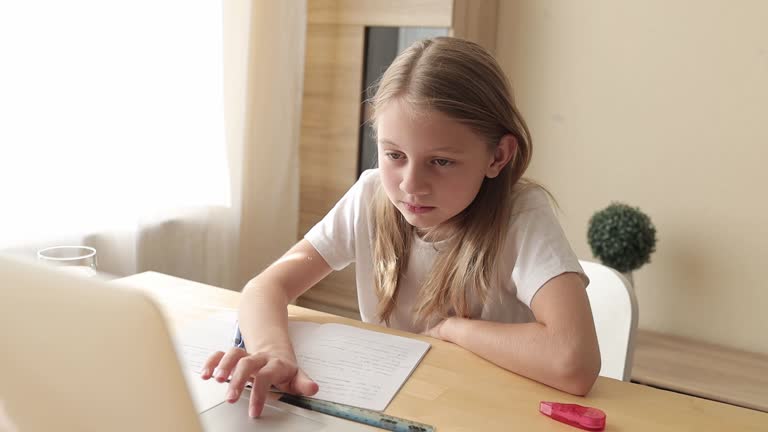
[587,202,656,273]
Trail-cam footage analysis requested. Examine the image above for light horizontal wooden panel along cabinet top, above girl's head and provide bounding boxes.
[307,0,453,27]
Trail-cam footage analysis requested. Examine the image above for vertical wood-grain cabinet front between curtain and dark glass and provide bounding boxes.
[297,20,365,317]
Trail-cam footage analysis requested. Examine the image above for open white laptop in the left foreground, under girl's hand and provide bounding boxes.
[0,255,378,432]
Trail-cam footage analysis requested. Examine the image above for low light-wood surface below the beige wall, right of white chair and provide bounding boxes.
[632,331,768,412]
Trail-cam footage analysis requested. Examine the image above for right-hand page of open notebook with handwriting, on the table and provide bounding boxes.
[294,324,430,411]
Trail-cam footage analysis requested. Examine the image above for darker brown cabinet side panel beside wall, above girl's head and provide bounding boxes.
[451,0,499,54]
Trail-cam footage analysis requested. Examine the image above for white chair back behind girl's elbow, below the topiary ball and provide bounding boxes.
[579,260,638,381]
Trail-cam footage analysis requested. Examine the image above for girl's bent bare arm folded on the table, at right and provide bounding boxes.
[429,273,600,395]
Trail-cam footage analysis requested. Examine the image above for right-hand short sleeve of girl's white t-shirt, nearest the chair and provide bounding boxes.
[507,187,588,308]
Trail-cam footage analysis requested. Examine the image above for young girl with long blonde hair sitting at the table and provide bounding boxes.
[202,37,600,417]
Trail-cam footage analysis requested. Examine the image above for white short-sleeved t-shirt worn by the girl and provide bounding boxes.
[304,169,587,333]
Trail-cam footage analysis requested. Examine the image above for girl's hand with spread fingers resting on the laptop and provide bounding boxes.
[201,348,319,417]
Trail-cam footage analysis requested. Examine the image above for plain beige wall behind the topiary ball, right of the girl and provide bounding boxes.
[497,0,768,353]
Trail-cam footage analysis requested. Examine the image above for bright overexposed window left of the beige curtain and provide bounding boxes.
[0,0,230,247]
